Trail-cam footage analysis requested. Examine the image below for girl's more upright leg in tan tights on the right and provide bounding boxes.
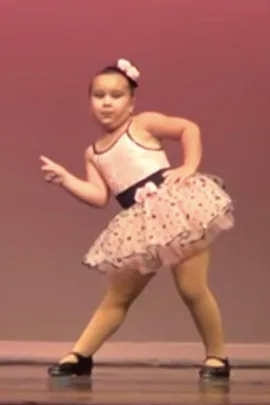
[173,246,227,367]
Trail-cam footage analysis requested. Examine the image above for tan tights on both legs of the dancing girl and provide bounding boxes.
[61,246,224,366]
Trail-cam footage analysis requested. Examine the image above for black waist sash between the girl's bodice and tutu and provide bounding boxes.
[115,168,169,208]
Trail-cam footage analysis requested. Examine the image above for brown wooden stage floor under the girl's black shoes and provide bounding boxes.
[0,365,270,405]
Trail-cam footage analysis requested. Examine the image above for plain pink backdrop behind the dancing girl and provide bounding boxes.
[0,0,270,342]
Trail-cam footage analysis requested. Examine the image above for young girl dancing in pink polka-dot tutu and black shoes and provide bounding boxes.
[40,59,234,378]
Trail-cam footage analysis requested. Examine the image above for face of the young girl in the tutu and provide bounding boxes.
[90,73,134,130]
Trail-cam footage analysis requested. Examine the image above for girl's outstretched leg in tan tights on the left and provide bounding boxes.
[49,271,153,375]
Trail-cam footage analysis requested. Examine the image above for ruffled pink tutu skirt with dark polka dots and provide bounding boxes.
[83,174,234,274]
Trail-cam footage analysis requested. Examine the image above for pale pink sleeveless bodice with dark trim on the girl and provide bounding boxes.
[91,132,170,195]
